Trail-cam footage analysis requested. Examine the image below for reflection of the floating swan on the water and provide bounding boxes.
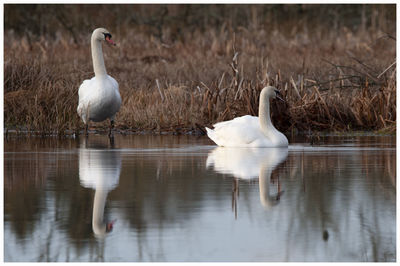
[206,147,288,212]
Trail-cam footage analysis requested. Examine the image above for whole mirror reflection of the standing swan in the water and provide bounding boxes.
[79,140,121,237]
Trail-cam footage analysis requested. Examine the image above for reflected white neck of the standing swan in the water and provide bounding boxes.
[92,189,108,235]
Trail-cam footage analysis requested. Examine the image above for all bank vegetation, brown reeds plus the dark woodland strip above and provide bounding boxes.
[4,5,396,134]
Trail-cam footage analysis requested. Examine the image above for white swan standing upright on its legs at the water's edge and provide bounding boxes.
[77,28,121,137]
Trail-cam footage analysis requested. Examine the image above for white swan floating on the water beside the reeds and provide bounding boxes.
[206,86,288,147]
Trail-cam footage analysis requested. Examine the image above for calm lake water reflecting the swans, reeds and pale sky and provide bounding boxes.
[4,135,396,262]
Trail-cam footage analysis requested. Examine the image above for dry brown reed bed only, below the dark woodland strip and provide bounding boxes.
[4,4,396,135]
